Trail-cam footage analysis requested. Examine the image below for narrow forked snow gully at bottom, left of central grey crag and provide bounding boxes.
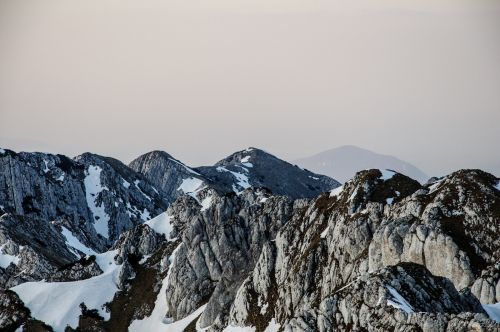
[128,243,186,332]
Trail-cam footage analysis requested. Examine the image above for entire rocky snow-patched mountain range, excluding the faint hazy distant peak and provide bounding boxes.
[0,148,500,332]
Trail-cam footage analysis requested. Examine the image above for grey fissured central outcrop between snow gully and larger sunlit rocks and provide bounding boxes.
[167,190,294,326]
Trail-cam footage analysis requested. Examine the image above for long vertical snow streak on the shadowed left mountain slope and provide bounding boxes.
[83,165,109,238]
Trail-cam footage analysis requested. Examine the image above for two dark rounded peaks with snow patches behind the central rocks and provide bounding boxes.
[130,148,340,202]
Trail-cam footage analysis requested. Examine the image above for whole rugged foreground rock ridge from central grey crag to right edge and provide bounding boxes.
[161,170,500,331]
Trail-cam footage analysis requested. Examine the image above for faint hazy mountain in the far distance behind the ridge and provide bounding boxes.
[294,145,429,183]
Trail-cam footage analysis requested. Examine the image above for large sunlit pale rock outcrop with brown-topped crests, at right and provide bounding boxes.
[222,170,500,331]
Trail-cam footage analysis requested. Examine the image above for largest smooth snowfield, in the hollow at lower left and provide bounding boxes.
[11,250,121,332]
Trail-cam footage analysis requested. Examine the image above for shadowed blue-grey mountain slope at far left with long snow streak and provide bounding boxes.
[0,150,168,246]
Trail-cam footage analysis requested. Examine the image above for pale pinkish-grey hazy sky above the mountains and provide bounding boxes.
[0,0,500,175]
